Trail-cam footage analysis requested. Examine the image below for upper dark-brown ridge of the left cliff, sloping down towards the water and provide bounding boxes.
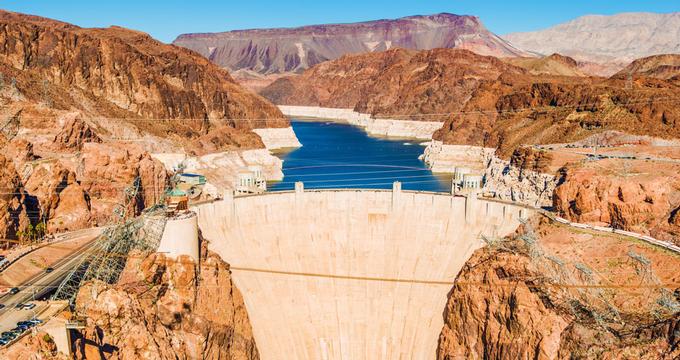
[0,12,285,131]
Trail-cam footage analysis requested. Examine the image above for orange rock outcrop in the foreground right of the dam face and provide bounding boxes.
[437,219,680,360]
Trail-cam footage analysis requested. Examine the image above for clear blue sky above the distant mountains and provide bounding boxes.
[0,0,680,42]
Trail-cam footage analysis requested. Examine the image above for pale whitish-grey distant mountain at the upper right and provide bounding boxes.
[503,12,680,75]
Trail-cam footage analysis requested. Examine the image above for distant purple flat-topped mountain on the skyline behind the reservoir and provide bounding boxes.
[173,13,526,74]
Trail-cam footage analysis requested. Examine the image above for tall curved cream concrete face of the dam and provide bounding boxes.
[193,188,528,359]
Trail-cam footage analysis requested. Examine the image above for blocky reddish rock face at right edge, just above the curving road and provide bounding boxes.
[553,162,680,243]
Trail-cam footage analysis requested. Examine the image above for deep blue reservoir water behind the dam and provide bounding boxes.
[268,120,451,192]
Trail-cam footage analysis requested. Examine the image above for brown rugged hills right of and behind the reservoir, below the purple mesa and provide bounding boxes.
[261,49,680,159]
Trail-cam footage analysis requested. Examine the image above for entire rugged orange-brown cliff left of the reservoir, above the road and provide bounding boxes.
[0,11,289,238]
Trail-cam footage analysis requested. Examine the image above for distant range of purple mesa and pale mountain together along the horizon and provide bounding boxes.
[173,12,680,77]
